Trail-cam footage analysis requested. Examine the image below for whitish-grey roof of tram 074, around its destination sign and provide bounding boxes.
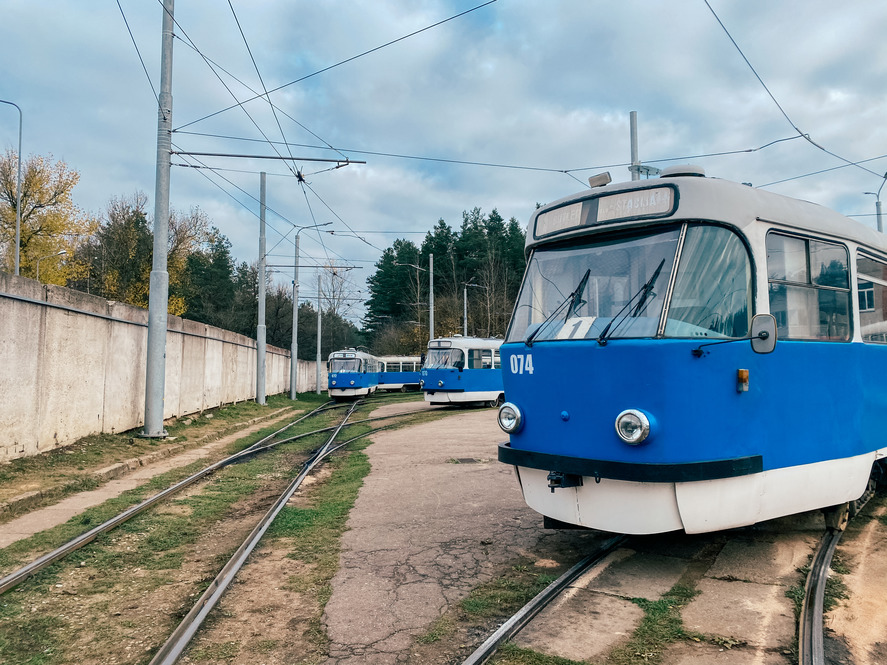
[526,167,887,252]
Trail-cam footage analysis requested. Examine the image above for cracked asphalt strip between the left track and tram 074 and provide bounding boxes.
[324,403,594,665]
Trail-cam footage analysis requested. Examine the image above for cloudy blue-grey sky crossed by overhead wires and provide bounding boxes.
[0,0,887,322]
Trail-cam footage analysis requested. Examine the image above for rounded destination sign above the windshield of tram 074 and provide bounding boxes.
[534,185,676,239]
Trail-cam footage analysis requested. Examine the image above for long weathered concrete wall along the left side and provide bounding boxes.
[0,273,326,461]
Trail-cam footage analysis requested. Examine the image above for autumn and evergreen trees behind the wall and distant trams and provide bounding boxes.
[0,149,524,360]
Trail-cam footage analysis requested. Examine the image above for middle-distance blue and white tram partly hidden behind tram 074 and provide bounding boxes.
[420,335,505,406]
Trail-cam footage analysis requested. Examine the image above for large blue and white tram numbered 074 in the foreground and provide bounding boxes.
[499,167,887,534]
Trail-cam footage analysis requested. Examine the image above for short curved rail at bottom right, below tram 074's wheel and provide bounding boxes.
[798,527,844,665]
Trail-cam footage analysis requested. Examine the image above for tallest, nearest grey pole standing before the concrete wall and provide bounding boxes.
[142,0,174,438]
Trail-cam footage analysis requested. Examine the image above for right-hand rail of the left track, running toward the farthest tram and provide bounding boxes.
[149,402,359,665]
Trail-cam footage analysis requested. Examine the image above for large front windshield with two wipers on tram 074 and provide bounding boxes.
[507,224,751,343]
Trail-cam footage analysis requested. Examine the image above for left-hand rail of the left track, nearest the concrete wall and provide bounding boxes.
[0,404,329,595]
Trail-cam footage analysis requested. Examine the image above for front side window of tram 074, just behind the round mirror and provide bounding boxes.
[767,233,851,341]
